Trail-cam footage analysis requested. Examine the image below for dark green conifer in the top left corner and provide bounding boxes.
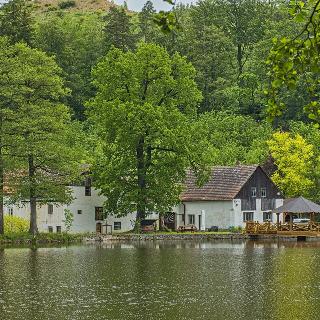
[0,0,33,45]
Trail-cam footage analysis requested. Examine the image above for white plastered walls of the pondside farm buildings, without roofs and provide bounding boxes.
[5,186,283,233]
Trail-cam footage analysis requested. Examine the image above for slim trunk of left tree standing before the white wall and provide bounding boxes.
[28,155,38,235]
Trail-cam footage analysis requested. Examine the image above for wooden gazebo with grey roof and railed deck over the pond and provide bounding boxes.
[246,197,320,236]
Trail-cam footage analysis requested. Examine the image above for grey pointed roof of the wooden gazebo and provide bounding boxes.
[273,197,320,213]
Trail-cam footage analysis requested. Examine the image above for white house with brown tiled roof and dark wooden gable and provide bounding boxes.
[173,166,283,230]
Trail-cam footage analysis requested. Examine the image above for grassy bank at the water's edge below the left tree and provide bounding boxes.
[0,232,88,244]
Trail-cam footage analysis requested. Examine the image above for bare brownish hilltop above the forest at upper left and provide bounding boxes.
[34,0,114,12]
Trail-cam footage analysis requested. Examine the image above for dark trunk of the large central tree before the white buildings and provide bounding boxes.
[136,137,146,223]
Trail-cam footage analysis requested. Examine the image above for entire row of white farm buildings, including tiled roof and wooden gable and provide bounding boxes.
[5,166,283,233]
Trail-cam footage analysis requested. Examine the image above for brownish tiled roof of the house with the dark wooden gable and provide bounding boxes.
[180,165,258,201]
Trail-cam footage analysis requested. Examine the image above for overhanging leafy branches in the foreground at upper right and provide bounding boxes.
[267,0,320,122]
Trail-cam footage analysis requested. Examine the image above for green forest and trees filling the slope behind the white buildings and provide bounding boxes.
[0,0,320,233]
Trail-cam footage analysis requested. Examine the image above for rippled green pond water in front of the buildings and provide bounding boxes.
[0,241,320,320]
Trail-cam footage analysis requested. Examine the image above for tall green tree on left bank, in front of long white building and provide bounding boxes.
[0,39,78,234]
